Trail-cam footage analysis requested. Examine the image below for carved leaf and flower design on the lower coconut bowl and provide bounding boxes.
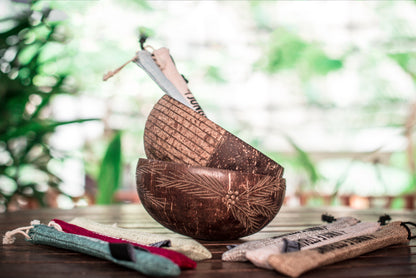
[138,164,285,233]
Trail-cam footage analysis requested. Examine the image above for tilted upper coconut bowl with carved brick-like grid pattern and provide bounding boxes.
[144,95,283,178]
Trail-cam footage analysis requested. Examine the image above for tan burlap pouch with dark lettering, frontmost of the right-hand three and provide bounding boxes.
[268,222,408,277]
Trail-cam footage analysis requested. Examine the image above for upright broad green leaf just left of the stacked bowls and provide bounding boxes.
[96,132,123,204]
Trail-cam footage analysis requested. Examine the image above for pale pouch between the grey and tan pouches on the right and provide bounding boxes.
[246,222,380,269]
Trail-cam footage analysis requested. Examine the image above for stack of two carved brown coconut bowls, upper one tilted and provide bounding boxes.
[136,95,285,240]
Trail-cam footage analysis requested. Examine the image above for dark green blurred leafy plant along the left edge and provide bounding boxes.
[0,1,95,209]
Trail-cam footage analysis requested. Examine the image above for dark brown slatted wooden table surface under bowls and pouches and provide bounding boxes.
[0,204,416,278]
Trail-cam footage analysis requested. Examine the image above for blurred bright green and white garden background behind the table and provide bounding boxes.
[0,0,416,211]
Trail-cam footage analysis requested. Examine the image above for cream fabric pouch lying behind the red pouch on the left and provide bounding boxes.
[70,218,212,261]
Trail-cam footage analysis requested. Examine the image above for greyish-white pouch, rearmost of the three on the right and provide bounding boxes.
[222,217,359,262]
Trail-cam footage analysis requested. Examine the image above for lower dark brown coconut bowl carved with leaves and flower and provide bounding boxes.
[136,159,285,240]
